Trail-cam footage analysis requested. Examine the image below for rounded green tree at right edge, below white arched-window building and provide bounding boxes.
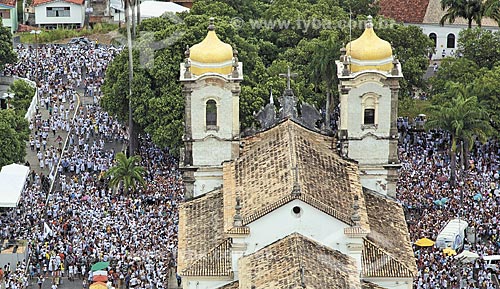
[457,28,500,68]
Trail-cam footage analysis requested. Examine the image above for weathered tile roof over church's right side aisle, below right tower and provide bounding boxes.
[363,188,417,275]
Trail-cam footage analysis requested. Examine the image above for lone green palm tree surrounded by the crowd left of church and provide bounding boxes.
[104,152,146,194]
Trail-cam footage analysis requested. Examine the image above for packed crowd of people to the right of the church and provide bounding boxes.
[397,125,500,289]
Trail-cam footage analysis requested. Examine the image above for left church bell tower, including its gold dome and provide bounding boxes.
[180,18,243,199]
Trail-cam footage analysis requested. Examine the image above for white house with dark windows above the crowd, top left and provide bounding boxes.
[32,0,86,29]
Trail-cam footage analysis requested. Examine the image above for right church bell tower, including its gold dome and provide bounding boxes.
[337,16,403,197]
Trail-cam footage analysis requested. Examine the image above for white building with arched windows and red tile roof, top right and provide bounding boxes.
[378,0,498,59]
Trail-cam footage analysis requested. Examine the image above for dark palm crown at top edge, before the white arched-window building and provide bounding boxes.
[439,0,484,28]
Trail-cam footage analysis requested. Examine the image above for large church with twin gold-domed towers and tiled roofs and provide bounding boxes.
[177,18,417,289]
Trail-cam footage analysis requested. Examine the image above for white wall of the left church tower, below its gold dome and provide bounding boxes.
[181,69,242,198]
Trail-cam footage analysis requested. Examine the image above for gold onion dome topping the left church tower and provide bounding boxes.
[189,18,233,75]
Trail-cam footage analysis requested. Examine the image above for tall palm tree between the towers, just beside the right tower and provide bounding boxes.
[310,35,340,129]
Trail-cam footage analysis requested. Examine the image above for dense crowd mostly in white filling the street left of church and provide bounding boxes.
[0,45,184,289]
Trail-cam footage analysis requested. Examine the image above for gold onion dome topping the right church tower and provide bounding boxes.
[345,16,393,72]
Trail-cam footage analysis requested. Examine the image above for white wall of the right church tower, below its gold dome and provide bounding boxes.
[337,62,402,196]
